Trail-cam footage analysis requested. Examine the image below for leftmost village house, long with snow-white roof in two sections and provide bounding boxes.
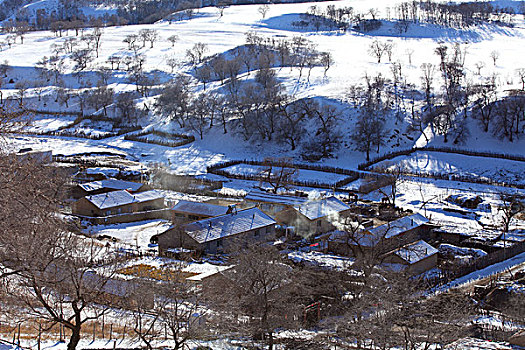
[73,190,164,217]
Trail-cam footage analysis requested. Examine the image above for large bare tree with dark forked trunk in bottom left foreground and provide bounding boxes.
[0,157,122,350]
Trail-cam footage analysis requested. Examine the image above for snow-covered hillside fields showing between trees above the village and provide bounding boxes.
[0,0,525,175]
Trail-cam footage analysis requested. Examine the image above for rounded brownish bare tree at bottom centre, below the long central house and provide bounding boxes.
[210,244,298,350]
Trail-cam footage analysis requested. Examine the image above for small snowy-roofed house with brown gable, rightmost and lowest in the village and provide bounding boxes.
[384,240,439,275]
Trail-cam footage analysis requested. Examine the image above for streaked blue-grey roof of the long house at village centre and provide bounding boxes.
[184,208,276,243]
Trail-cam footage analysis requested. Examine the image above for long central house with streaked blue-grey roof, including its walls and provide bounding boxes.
[157,208,276,255]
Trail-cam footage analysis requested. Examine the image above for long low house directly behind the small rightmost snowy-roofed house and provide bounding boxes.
[323,214,434,256]
